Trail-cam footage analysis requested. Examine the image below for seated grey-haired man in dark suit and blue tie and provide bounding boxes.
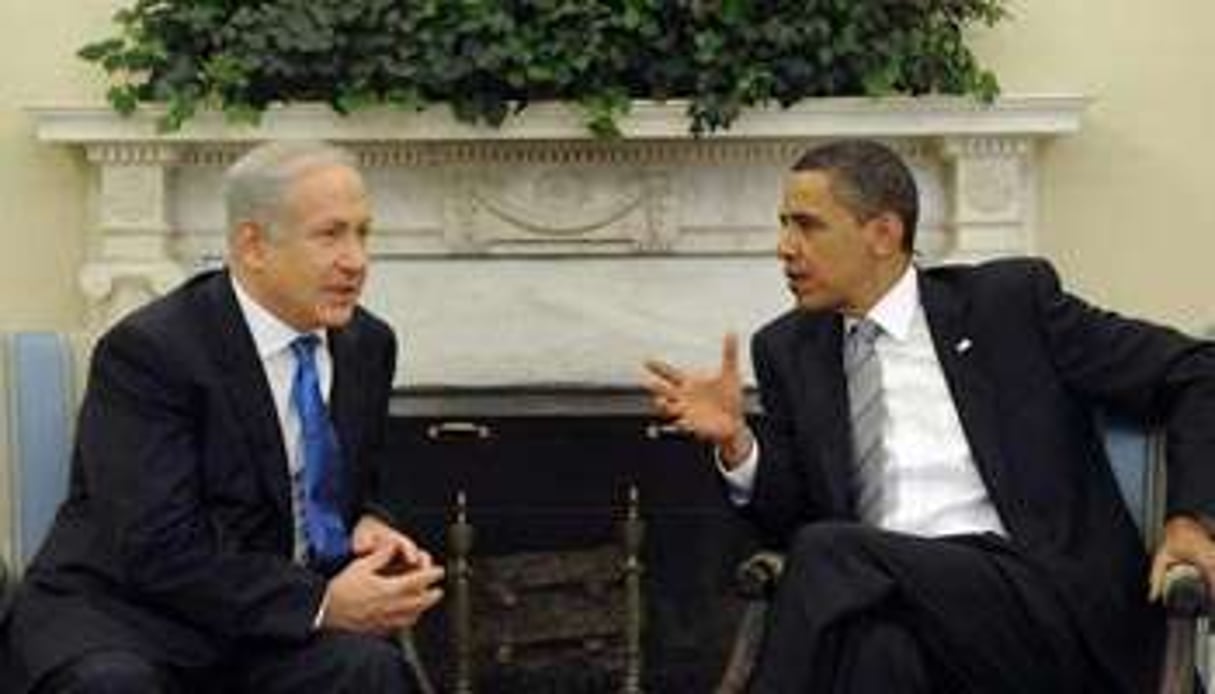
[6,142,442,694]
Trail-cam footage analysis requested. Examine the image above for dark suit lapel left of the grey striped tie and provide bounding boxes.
[793,315,855,517]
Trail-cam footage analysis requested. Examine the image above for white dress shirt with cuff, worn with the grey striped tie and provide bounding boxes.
[722,266,1007,537]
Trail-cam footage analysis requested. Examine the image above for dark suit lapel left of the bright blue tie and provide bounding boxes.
[207,271,290,515]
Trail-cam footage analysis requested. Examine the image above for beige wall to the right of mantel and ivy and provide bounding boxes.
[977,0,1215,331]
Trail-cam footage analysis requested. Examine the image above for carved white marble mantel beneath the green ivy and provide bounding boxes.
[32,96,1087,385]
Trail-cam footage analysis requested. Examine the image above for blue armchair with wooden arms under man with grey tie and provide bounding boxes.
[717,418,1210,694]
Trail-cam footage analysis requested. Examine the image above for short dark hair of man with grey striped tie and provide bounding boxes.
[792,140,920,253]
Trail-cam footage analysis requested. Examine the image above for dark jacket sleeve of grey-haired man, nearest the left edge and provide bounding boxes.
[78,323,326,639]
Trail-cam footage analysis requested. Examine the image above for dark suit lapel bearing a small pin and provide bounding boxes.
[920,272,1005,500]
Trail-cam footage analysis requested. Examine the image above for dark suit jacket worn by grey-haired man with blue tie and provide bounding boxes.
[10,272,396,681]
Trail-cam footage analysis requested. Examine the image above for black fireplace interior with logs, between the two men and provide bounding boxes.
[385,387,755,694]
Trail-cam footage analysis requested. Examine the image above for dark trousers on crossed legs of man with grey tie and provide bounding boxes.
[753,523,1090,694]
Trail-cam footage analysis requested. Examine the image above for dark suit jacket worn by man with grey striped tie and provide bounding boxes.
[747,260,1215,693]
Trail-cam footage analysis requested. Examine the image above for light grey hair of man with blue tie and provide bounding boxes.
[224,140,357,237]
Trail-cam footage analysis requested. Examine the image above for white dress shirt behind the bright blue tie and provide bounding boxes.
[232,276,333,563]
